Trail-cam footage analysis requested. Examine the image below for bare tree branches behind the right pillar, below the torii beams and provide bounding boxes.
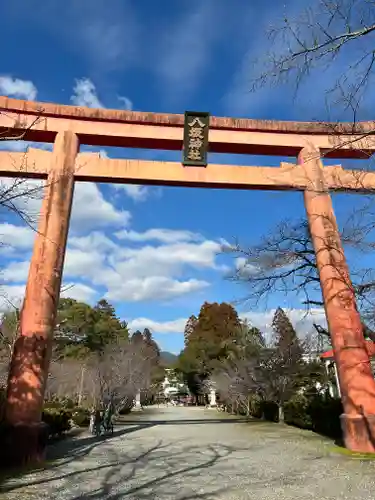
[223,204,375,339]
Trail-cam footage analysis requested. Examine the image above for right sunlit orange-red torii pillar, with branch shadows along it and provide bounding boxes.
[298,147,375,453]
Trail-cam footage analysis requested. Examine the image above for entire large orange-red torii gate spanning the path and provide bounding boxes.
[0,97,375,461]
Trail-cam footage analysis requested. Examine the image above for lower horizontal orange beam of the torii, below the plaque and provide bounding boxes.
[0,148,375,192]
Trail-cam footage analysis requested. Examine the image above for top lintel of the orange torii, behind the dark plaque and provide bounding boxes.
[0,96,375,158]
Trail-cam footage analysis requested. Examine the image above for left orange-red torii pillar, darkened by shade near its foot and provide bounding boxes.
[1,131,79,465]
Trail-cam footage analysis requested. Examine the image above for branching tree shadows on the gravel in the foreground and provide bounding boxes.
[2,441,256,500]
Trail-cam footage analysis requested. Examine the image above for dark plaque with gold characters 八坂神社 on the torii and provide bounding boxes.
[182,111,210,167]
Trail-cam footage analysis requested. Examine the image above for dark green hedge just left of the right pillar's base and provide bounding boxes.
[284,394,343,439]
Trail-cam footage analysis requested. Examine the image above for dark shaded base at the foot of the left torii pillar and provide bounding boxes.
[0,422,48,469]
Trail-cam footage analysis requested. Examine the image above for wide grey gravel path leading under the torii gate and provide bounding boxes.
[0,407,375,500]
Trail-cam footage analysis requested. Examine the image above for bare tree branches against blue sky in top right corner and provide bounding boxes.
[253,0,375,121]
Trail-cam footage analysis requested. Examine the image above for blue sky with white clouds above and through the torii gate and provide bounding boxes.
[0,0,372,352]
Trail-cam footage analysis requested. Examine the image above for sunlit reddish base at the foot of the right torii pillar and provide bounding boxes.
[340,414,375,453]
